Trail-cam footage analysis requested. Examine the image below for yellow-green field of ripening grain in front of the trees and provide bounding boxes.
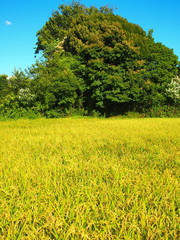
[0,118,180,240]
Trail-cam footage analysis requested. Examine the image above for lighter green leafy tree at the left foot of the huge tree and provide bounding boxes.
[30,53,83,112]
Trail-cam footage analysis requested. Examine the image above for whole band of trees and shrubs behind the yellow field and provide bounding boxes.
[0,2,180,117]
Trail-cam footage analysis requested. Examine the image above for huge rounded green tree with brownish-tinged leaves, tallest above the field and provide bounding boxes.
[33,2,178,114]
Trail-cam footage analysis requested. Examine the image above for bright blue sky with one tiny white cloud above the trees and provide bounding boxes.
[0,0,180,75]
